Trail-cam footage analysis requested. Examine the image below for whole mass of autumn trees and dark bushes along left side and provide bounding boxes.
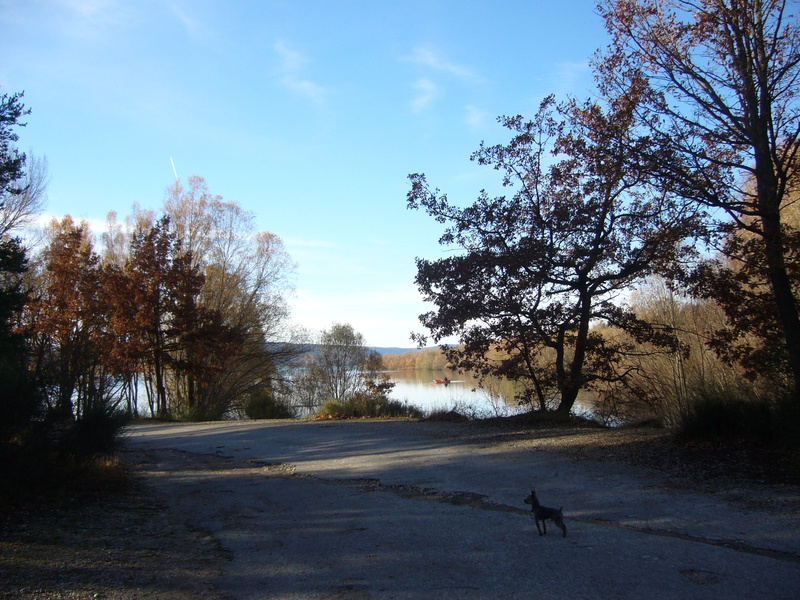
[0,93,303,498]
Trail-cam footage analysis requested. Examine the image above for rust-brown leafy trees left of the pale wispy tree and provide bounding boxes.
[27,217,244,418]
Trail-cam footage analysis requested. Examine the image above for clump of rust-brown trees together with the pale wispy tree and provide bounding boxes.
[24,178,298,419]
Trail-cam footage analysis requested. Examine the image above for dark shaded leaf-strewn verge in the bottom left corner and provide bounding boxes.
[0,468,227,600]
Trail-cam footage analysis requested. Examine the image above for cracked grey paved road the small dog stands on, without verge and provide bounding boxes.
[126,421,800,600]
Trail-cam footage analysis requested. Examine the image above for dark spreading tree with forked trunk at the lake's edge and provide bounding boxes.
[408,97,695,416]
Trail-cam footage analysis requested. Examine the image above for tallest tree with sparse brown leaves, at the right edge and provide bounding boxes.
[596,0,800,399]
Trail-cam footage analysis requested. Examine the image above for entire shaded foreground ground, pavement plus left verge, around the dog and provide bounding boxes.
[0,421,800,600]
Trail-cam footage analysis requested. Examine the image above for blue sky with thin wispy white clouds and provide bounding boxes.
[0,0,608,348]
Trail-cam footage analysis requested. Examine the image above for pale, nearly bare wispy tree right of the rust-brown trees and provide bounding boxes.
[159,175,299,414]
